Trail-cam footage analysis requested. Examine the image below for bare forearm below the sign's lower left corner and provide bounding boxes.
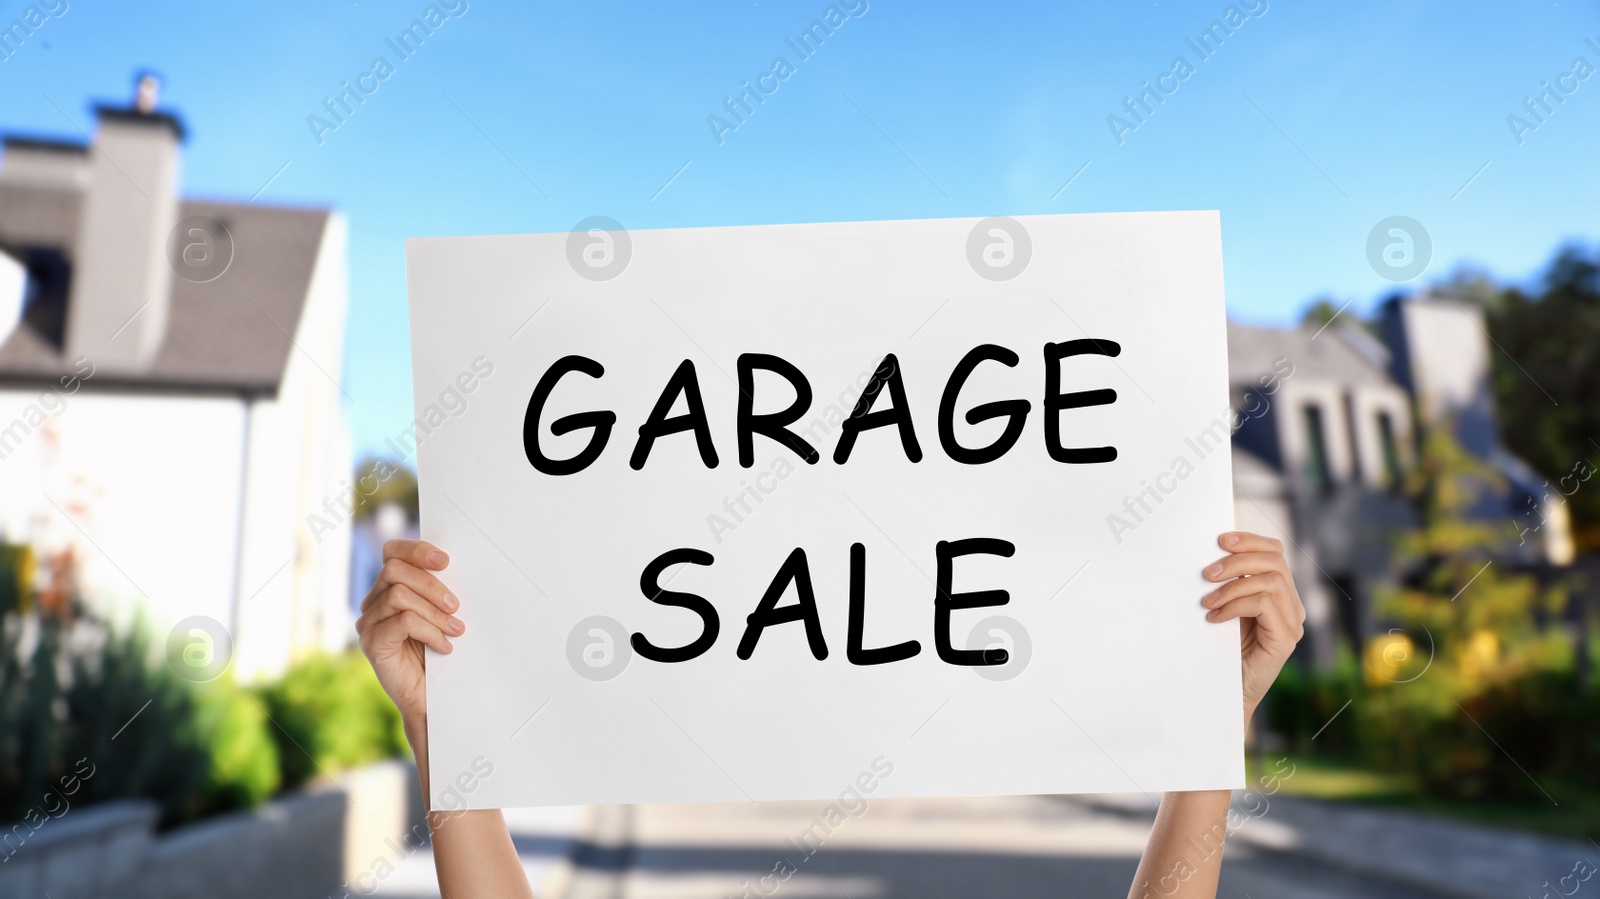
[405,718,533,899]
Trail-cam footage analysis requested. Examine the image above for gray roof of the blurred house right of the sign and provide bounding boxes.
[1227,322,1394,386]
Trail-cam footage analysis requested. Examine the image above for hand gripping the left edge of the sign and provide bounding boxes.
[355,541,467,723]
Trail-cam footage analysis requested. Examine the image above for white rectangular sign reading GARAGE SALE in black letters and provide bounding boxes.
[406,213,1245,808]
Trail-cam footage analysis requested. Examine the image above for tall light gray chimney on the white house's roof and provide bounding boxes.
[66,74,184,373]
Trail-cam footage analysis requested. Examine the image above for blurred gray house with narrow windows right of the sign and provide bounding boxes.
[1227,293,1573,667]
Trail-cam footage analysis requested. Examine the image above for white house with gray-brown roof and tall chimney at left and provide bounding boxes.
[0,77,350,680]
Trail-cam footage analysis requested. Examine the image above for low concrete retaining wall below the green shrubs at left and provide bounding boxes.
[0,761,426,899]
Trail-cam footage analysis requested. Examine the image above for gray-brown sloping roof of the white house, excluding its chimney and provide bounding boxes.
[0,184,330,394]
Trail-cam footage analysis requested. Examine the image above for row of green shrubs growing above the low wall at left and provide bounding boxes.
[0,614,406,825]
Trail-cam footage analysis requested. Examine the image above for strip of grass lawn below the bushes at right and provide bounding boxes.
[1246,753,1600,841]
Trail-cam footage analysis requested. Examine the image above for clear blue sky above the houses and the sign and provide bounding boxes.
[0,0,1600,453]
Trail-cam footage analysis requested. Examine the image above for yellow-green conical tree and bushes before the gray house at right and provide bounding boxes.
[1269,430,1600,803]
